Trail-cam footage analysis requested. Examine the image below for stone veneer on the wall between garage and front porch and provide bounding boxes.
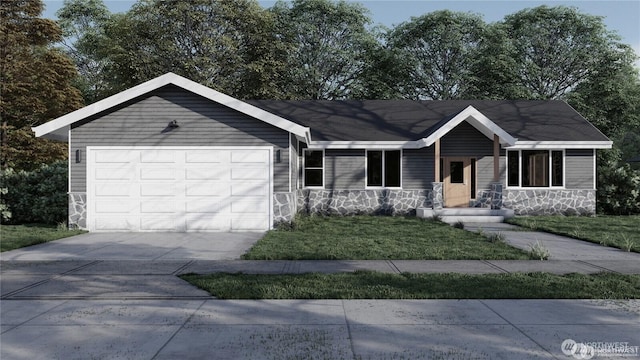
[297,189,432,215]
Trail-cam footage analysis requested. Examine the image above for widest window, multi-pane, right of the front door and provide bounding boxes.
[507,150,564,187]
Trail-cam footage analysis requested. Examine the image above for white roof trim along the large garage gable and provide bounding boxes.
[32,73,311,140]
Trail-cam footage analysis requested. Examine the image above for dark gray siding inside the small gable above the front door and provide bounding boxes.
[440,121,493,157]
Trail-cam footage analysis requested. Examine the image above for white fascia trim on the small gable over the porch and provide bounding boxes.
[419,105,517,147]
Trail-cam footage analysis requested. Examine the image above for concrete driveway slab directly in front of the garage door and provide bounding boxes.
[0,232,264,261]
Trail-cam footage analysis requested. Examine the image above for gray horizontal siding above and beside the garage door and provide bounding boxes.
[70,86,290,192]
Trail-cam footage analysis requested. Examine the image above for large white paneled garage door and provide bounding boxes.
[87,147,273,232]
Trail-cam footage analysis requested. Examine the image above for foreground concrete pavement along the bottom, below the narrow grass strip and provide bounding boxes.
[0,300,640,360]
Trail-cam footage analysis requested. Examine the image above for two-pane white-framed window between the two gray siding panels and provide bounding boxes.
[367,150,402,187]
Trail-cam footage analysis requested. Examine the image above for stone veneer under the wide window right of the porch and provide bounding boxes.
[502,189,596,215]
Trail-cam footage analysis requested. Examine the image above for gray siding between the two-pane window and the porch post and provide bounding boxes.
[402,146,435,190]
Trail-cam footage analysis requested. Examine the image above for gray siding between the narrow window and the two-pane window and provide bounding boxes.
[324,149,366,190]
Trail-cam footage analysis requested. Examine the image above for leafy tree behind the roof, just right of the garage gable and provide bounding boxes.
[271,0,379,99]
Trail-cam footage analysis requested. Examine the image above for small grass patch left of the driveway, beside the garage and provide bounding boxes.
[0,224,86,251]
